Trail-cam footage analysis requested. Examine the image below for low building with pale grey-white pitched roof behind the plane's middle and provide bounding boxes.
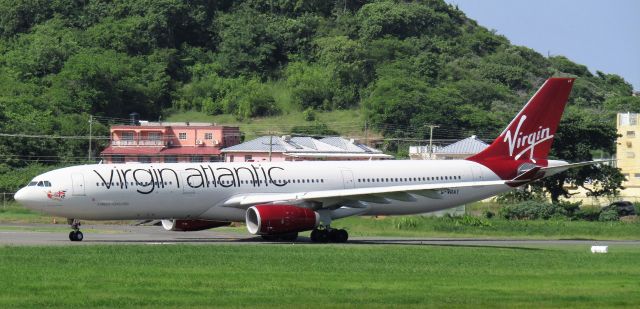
[222,136,393,162]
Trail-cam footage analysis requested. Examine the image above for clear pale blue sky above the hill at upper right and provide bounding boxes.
[445,0,640,91]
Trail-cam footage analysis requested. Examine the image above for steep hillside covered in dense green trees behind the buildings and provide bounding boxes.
[0,0,640,191]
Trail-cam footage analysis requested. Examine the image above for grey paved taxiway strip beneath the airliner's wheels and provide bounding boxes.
[0,223,640,247]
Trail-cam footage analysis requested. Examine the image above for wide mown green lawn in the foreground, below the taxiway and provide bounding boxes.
[0,245,640,308]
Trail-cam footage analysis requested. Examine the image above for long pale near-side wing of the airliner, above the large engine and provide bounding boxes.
[223,180,506,208]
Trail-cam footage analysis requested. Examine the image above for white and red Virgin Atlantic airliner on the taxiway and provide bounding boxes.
[14,78,599,243]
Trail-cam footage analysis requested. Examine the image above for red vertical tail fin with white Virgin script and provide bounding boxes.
[467,78,574,179]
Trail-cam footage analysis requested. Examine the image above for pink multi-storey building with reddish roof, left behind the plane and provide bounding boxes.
[100,121,240,163]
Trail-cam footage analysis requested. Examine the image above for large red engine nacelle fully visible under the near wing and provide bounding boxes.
[246,205,320,235]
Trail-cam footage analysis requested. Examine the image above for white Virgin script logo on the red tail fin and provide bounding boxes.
[503,115,553,163]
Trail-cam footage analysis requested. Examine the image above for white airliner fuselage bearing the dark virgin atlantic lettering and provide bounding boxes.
[16,160,512,221]
